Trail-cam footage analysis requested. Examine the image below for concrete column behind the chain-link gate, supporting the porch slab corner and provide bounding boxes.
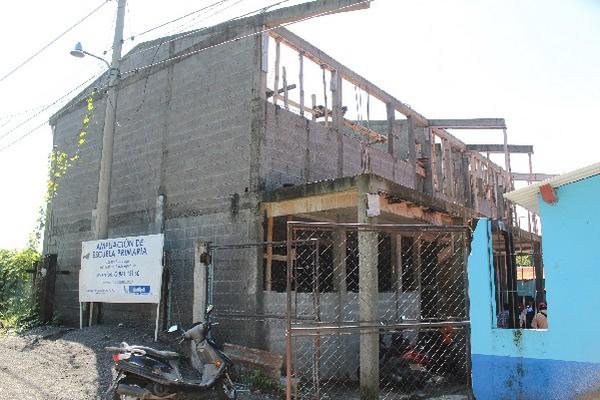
[357,180,379,400]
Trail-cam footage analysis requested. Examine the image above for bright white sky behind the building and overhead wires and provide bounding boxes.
[0,0,600,248]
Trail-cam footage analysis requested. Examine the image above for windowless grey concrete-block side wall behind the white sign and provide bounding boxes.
[45,31,260,325]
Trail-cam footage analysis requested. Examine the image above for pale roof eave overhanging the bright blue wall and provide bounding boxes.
[504,163,600,214]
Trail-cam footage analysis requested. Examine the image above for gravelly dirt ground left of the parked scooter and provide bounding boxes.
[0,326,266,400]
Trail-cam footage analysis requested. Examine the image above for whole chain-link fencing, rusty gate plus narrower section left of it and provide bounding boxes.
[207,222,470,400]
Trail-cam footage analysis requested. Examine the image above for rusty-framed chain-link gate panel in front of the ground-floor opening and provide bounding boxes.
[286,222,470,400]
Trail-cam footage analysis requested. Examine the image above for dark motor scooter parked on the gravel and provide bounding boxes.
[106,306,237,400]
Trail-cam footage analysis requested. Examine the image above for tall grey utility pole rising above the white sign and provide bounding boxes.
[94,0,127,239]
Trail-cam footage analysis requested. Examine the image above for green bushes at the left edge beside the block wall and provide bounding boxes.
[0,248,41,329]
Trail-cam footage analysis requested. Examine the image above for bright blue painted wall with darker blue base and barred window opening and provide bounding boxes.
[468,176,600,400]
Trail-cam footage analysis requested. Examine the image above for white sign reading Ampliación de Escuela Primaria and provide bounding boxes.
[79,234,164,303]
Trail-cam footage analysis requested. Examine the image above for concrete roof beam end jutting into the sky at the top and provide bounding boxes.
[263,0,372,28]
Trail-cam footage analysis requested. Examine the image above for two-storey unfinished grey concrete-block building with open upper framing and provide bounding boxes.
[44,0,544,364]
